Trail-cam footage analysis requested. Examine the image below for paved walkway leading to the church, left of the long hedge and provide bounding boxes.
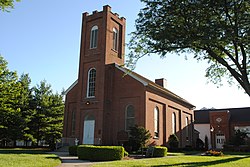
[50,152,96,167]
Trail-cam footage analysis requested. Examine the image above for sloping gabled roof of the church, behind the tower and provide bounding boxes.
[115,64,195,109]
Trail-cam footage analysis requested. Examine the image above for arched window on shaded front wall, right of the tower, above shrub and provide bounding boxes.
[125,105,135,131]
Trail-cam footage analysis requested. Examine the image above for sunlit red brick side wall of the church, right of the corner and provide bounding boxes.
[145,89,193,147]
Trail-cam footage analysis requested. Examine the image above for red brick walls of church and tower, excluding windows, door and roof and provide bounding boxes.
[64,6,193,147]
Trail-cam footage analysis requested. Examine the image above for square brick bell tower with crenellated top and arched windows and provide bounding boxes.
[77,5,126,144]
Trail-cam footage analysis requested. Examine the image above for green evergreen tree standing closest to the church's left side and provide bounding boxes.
[29,81,64,149]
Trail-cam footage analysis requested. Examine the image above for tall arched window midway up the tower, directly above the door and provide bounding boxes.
[87,68,96,97]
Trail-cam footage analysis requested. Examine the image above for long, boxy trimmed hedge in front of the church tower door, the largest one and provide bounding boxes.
[77,145,124,161]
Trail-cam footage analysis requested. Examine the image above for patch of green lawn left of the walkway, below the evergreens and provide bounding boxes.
[0,149,61,167]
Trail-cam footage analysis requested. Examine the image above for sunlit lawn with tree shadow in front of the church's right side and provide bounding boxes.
[93,153,250,167]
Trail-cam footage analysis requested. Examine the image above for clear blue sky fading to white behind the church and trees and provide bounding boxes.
[0,0,250,109]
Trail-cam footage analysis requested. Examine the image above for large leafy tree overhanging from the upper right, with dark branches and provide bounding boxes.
[127,0,250,96]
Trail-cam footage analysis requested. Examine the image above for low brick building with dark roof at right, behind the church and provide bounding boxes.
[194,107,250,149]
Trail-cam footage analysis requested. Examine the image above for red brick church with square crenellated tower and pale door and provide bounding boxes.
[63,5,194,147]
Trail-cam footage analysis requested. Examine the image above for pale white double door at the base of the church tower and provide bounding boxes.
[83,120,95,144]
